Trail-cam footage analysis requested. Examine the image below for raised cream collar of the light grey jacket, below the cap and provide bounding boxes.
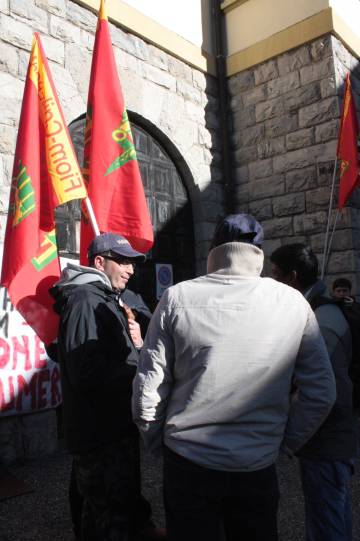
[207,241,264,276]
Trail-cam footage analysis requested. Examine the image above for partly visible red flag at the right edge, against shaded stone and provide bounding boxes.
[337,74,359,209]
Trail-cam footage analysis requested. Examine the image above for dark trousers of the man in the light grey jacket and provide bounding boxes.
[164,442,279,541]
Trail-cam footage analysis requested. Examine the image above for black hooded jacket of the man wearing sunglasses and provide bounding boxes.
[51,265,138,454]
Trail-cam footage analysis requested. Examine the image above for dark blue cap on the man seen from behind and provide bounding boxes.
[211,214,264,248]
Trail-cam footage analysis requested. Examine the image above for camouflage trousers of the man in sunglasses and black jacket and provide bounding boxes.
[73,435,151,541]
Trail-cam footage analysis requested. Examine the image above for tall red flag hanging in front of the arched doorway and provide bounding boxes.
[80,0,154,264]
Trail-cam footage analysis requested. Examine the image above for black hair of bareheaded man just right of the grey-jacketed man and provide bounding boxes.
[270,243,319,288]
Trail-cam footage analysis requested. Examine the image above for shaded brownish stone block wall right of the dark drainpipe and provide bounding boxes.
[228,35,360,293]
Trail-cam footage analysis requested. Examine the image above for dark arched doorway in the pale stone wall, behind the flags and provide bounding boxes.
[56,112,195,308]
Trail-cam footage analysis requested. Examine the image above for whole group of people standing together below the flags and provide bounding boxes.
[51,214,358,541]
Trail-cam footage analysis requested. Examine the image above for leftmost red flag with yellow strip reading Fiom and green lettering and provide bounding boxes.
[1,33,86,343]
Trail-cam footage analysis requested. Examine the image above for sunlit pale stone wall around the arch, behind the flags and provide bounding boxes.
[0,0,223,272]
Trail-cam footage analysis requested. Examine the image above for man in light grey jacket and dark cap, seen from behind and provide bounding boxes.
[133,214,335,541]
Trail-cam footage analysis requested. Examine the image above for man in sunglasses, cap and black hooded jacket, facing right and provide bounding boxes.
[51,233,164,541]
